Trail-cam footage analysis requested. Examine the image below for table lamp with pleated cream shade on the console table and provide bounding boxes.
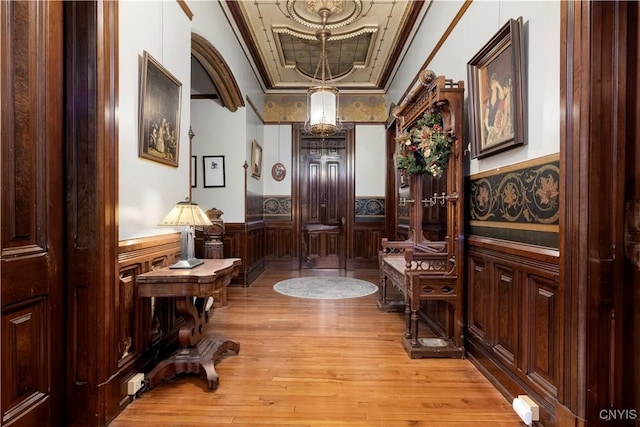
[158,198,212,268]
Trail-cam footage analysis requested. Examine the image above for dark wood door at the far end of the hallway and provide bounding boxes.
[300,134,347,269]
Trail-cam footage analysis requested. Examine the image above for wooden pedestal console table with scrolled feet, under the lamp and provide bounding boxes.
[136,258,241,390]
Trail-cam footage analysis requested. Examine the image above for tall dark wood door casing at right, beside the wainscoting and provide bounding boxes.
[559,1,638,425]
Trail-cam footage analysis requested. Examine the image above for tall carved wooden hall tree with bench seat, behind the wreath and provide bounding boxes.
[378,70,464,358]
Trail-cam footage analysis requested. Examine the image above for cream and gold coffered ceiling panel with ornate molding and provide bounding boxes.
[222,0,426,93]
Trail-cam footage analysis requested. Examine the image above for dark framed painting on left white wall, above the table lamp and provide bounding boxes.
[139,51,182,167]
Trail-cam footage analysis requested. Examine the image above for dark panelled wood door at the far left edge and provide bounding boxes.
[0,1,65,426]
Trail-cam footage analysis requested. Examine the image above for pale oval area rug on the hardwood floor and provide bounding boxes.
[273,276,378,299]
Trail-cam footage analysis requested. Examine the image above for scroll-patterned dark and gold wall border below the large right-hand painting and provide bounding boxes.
[467,154,560,248]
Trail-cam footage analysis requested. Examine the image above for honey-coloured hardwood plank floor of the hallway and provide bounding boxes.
[110,270,522,427]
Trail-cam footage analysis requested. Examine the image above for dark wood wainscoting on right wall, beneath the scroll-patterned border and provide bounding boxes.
[466,236,563,425]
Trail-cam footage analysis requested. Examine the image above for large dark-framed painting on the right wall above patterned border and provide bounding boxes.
[467,18,527,158]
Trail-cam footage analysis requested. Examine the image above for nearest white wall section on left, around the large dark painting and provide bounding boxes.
[118,1,191,240]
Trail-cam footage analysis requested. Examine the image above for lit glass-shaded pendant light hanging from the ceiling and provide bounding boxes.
[304,6,342,138]
